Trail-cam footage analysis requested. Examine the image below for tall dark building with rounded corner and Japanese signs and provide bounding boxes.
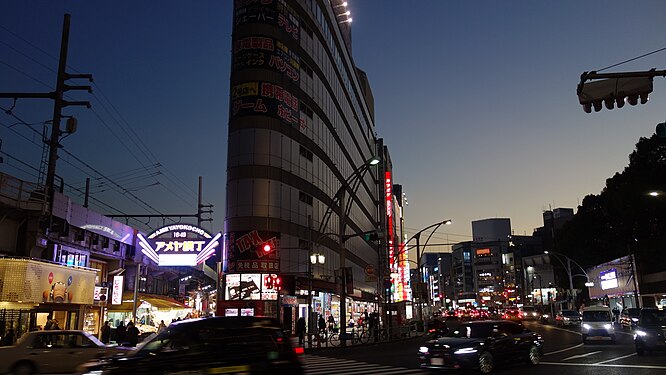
[218,0,382,326]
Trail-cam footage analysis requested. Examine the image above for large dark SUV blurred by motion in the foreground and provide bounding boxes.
[80,316,303,375]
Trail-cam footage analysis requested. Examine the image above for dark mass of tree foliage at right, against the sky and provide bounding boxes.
[555,135,666,273]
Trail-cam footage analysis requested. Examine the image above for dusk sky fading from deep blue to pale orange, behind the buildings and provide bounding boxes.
[0,0,666,256]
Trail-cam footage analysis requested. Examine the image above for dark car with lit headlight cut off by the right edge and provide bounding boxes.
[634,308,666,355]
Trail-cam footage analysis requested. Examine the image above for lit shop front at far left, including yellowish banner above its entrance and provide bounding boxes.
[0,258,99,344]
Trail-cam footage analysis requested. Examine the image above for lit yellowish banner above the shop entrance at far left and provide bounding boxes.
[0,259,95,305]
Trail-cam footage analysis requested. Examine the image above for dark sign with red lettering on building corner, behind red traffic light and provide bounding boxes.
[225,230,280,274]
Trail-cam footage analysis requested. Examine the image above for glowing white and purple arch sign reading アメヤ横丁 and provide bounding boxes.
[137,224,222,266]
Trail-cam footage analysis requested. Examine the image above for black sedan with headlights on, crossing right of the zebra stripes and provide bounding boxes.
[418,320,543,374]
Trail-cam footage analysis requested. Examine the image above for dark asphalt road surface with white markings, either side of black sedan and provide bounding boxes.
[303,322,666,375]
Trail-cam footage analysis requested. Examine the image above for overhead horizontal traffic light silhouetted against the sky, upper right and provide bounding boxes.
[577,77,652,113]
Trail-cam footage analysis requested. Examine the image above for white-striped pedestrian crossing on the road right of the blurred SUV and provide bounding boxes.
[301,354,428,375]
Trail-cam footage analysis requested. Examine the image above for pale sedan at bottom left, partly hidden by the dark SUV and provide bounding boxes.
[0,330,131,375]
